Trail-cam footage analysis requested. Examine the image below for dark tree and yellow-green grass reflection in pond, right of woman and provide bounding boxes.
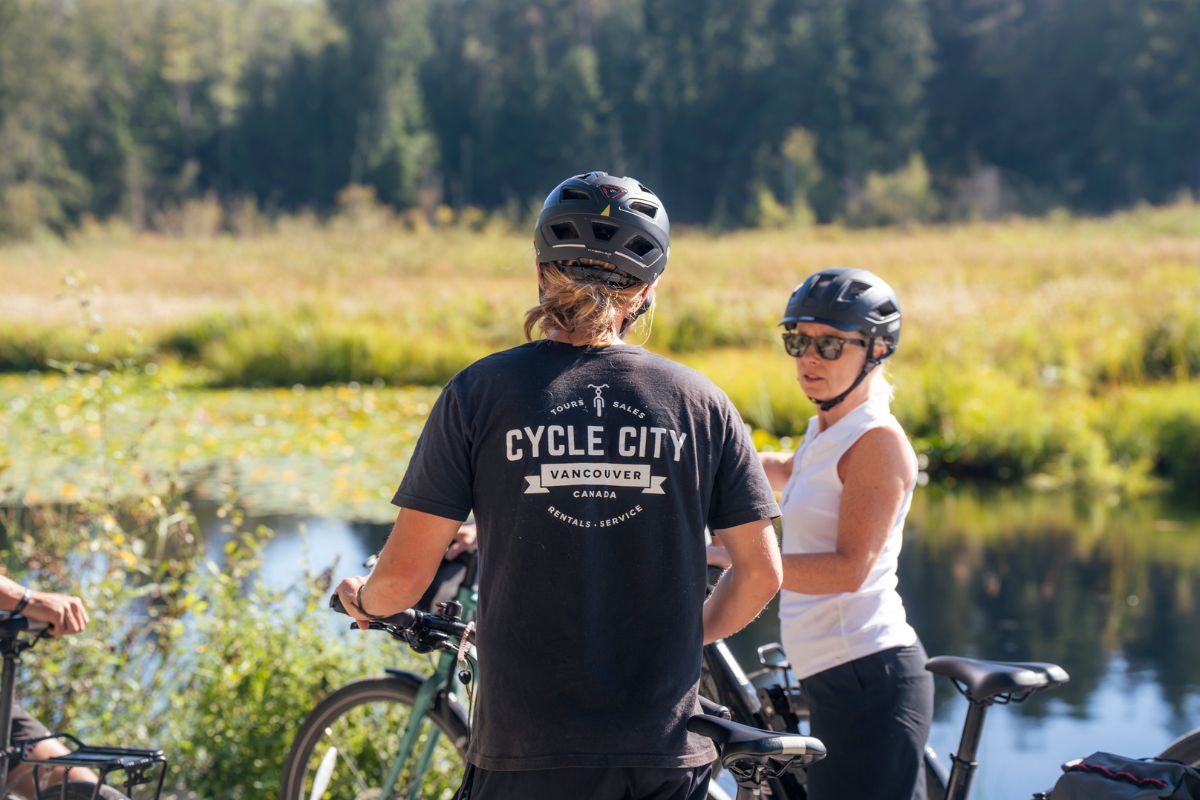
[900,494,1200,727]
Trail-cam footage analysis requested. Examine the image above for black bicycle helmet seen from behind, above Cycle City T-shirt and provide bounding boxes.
[533,172,671,283]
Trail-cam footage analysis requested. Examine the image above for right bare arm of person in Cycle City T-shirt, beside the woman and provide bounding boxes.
[704,519,782,644]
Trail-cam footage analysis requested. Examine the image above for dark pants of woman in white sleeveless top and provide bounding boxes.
[800,642,934,800]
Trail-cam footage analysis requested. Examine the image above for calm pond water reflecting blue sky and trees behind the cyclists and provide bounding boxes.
[189,491,1200,800]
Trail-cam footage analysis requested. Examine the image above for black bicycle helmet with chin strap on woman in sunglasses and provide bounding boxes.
[779,266,900,411]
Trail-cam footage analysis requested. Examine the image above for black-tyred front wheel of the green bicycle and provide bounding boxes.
[280,675,468,800]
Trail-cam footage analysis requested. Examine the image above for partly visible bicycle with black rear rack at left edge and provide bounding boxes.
[0,614,167,800]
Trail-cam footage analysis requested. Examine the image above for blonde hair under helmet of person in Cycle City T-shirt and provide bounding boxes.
[524,259,646,342]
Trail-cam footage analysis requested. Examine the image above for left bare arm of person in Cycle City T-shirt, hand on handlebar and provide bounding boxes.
[337,509,461,627]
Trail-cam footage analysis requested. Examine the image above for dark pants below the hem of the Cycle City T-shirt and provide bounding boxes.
[458,765,712,800]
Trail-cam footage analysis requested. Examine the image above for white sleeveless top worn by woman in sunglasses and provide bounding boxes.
[779,397,917,678]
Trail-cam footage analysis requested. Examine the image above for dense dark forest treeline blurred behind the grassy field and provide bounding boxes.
[0,0,1200,237]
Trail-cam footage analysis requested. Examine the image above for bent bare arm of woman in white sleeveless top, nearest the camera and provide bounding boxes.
[784,428,917,595]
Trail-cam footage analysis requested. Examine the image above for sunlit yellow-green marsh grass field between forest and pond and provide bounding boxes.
[0,203,1200,495]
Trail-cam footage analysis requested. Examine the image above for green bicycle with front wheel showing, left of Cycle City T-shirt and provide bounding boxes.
[280,553,479,800]
